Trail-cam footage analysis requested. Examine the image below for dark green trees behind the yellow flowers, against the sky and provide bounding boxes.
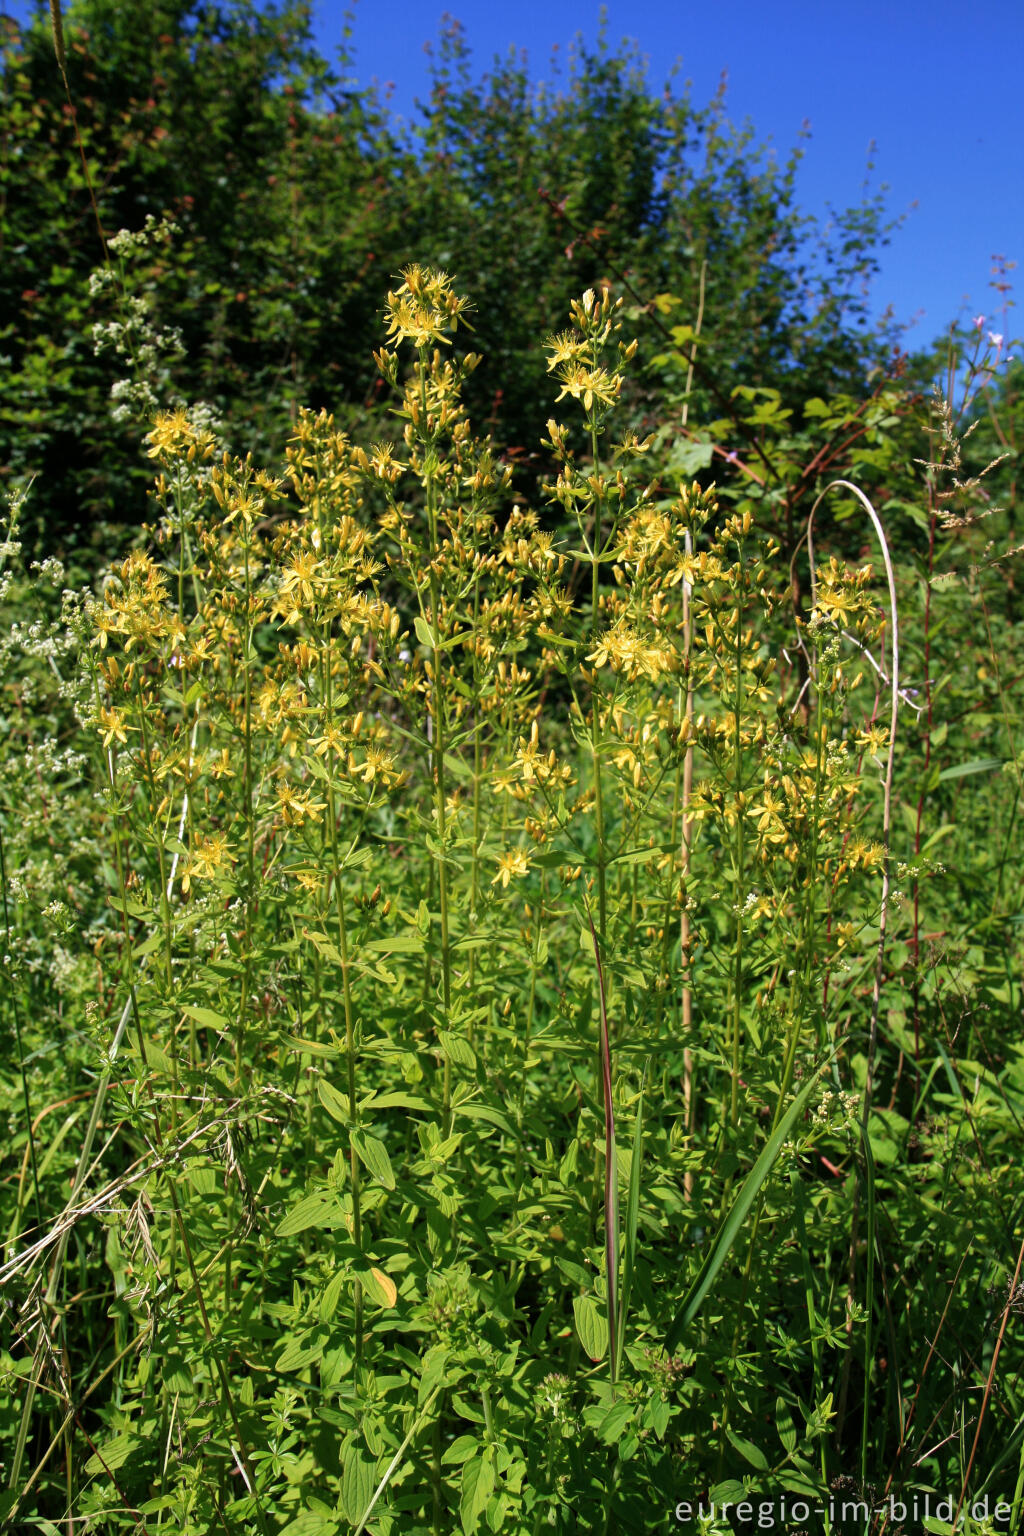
[0,0,890,552]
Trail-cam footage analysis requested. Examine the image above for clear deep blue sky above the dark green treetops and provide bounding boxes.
[0,0,1024,346]
